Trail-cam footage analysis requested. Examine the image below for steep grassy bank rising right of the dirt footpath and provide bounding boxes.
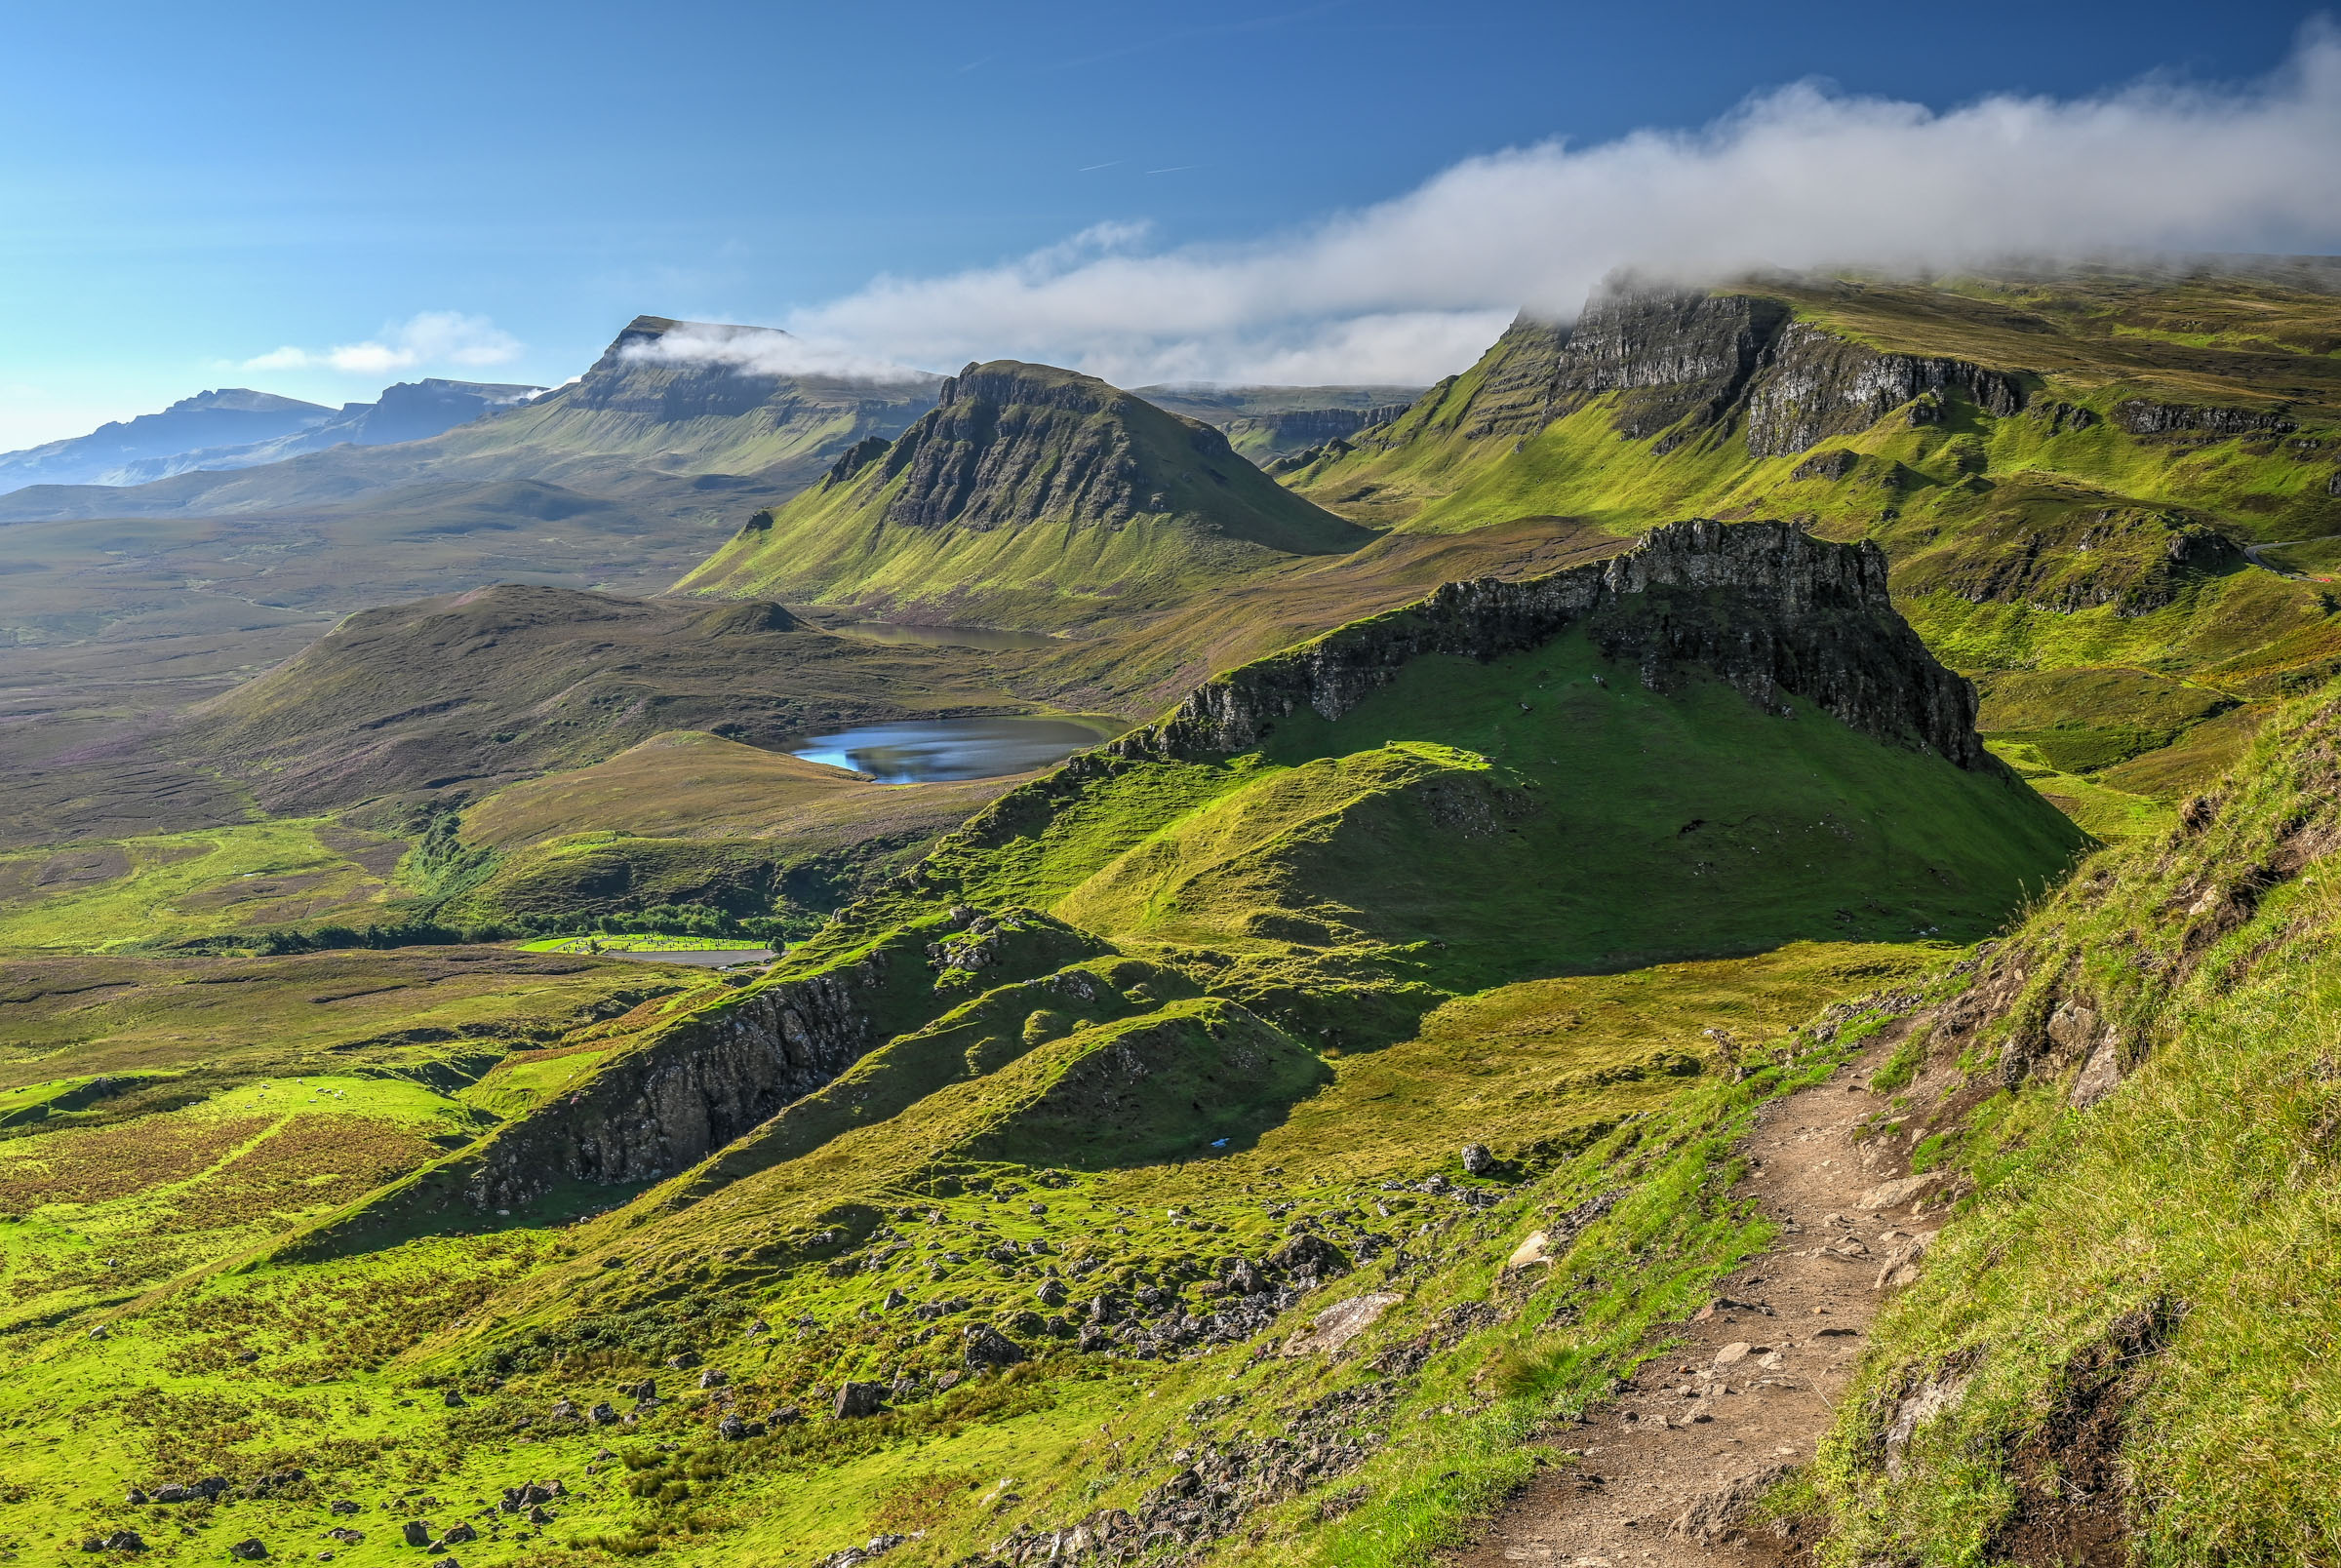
[1812,688,2341,1563]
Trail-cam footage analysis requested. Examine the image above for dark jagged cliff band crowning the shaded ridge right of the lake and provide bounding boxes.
[1132,520,1990,770]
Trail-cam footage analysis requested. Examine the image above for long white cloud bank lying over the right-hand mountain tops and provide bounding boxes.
[789,23,2341,386]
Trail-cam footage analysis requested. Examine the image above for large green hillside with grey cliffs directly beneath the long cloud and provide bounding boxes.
[1286,262,2341,831]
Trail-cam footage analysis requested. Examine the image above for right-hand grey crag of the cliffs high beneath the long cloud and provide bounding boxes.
[1746,321,2025,456]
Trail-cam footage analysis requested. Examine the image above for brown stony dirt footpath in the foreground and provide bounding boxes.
[1449,1041,1933,1568]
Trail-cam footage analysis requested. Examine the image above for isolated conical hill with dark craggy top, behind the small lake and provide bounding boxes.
[677,361,1369,625]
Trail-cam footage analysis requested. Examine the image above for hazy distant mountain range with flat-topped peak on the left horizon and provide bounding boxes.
[0,316,941,522]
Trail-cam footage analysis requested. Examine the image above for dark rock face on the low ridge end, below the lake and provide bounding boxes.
[466,961,880,1207]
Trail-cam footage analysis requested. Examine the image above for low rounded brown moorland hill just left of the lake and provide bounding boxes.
[171,585,1020,809]
